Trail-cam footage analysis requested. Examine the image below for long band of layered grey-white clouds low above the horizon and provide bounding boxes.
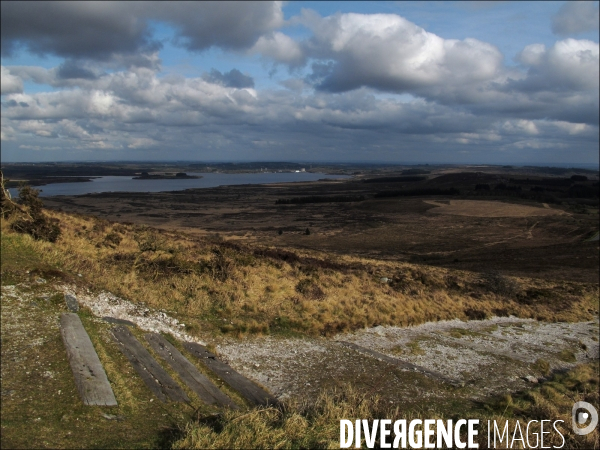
[2,61,597,159]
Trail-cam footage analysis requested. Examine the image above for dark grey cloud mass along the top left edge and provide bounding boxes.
[1,1,283,63]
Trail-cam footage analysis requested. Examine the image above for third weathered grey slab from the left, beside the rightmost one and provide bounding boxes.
[144,333,238,409]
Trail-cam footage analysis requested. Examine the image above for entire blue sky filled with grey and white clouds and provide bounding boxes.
[1,1,599,165]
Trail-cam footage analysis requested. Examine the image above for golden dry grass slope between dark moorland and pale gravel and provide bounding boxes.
[2,207,598,336]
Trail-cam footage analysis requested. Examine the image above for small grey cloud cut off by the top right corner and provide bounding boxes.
[552,1,600,35]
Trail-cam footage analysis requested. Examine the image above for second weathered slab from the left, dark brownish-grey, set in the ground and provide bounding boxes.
[112,325,190,402]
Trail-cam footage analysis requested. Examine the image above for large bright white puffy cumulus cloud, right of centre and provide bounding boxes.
[302,12,503,92]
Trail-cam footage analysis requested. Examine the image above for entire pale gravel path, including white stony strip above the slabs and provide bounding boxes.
[2,285,599,404]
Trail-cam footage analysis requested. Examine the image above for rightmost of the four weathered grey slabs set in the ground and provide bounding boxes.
[183,342,279,405]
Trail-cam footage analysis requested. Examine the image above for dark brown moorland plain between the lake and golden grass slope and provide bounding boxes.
[45,163,599,282]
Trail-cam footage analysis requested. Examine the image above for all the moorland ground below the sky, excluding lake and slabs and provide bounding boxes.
[2,163,599,448]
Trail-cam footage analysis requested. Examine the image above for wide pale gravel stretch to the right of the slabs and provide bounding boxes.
[217,317,598,401]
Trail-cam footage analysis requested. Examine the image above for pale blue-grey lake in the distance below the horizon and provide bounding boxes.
[9,172,350,197]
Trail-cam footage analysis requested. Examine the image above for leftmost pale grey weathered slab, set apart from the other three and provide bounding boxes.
[60,313,117,406]
